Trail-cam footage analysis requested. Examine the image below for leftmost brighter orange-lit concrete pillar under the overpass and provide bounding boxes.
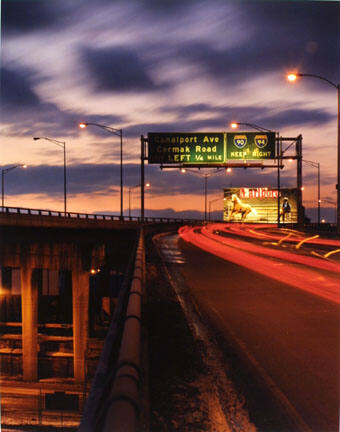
[20,262,39,381]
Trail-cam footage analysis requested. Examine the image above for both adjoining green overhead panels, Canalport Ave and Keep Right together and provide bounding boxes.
[148,132,275,165]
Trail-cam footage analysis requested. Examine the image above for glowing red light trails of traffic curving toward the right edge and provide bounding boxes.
[179,224,340,304]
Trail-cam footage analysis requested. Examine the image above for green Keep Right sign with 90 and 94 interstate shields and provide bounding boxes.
[226,132,275,160]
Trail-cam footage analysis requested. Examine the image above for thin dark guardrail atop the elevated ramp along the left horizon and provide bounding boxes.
[0,206,210,223]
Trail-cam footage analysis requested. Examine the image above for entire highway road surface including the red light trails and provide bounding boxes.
[160,224,340,432]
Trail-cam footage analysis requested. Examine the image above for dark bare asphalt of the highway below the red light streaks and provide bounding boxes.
[164,237,340,432]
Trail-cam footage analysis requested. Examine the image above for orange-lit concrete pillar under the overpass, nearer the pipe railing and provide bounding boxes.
[72,268,89,382]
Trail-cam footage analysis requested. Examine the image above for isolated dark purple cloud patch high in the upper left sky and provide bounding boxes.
[81,47,169,92]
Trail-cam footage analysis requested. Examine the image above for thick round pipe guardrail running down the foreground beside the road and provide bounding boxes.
[78,230,145,432]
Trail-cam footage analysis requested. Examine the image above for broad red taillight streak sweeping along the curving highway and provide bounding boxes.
[179,227,340,304]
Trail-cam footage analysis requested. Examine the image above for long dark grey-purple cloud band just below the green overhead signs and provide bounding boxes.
[6,163,296,200]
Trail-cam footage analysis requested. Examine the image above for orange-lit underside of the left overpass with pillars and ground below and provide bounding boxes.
[0,218,139,427]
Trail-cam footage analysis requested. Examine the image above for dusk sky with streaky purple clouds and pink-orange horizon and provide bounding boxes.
[0,0,340,222]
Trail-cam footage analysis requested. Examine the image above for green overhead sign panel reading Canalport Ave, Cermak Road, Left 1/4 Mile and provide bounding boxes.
[148,132,225,164]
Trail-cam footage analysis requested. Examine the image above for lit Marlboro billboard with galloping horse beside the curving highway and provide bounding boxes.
[223,187,298,224]
